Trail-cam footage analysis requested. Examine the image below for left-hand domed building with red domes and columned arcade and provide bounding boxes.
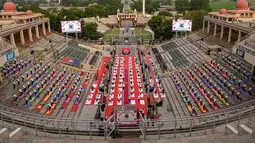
[0,2,51,47]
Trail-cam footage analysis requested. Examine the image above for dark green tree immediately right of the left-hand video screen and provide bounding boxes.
[82,22,103,40]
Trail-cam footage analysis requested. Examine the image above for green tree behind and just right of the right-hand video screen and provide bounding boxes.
[183,10,208,31]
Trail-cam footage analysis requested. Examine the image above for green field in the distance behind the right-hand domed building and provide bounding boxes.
[210,0,236,11]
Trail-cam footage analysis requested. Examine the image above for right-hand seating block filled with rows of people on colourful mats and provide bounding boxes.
[163,56,254,116]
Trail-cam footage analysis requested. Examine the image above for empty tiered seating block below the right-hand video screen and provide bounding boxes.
[152,38,209,71]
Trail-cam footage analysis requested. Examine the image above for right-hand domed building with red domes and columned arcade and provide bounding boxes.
[203,0,255,45]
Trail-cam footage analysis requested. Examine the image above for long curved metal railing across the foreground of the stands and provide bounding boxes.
[0,100,255,139]
